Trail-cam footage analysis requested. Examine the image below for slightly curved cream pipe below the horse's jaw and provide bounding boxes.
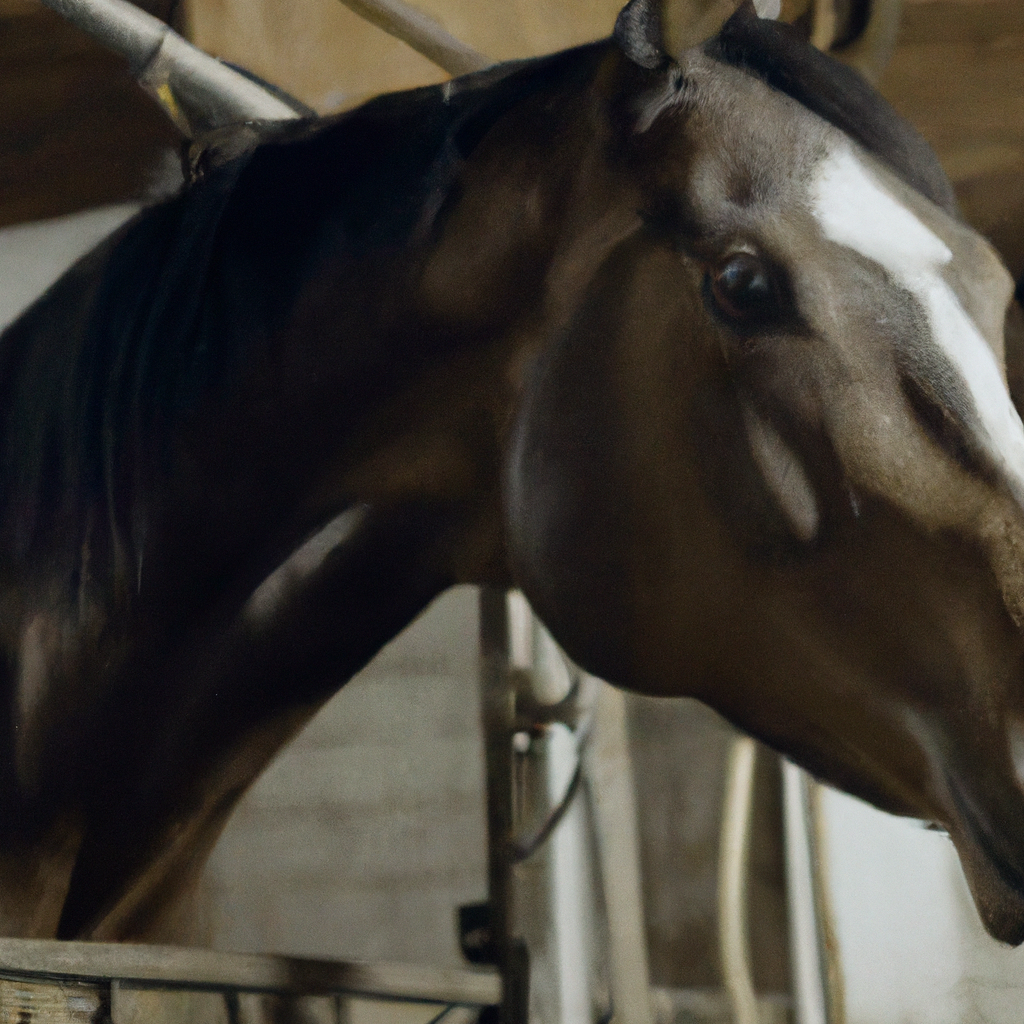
[718,736,758,1024]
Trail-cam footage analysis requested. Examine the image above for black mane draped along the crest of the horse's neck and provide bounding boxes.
[0,44,601,557]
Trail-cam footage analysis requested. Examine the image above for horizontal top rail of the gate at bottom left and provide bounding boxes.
[0,939,501,1007]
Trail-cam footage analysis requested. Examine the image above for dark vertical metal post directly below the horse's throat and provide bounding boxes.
[479,587,529,1024]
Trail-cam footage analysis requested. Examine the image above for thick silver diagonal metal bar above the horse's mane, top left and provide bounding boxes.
[43,0,303,137]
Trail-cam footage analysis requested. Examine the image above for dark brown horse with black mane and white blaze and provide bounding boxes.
[0,0,1024,943]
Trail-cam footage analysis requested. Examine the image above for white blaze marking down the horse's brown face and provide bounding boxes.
[811,146,1024,498]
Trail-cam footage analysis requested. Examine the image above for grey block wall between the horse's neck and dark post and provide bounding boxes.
[201,588,486,967]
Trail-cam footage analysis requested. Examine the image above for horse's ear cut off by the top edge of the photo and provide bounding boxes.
[614,0,750,69]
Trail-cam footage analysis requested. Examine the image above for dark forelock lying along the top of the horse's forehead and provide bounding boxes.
[705,5,956,216]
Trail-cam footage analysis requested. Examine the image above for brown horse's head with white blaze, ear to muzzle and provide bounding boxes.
[504,0,1024,943]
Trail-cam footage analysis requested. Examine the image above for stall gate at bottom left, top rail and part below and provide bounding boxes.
[0,939,501,1024]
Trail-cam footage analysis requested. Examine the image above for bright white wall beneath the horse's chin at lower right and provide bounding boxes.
[822,788,1024,1024]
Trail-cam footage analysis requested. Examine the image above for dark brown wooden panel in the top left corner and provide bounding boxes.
[0,0,179,226]
